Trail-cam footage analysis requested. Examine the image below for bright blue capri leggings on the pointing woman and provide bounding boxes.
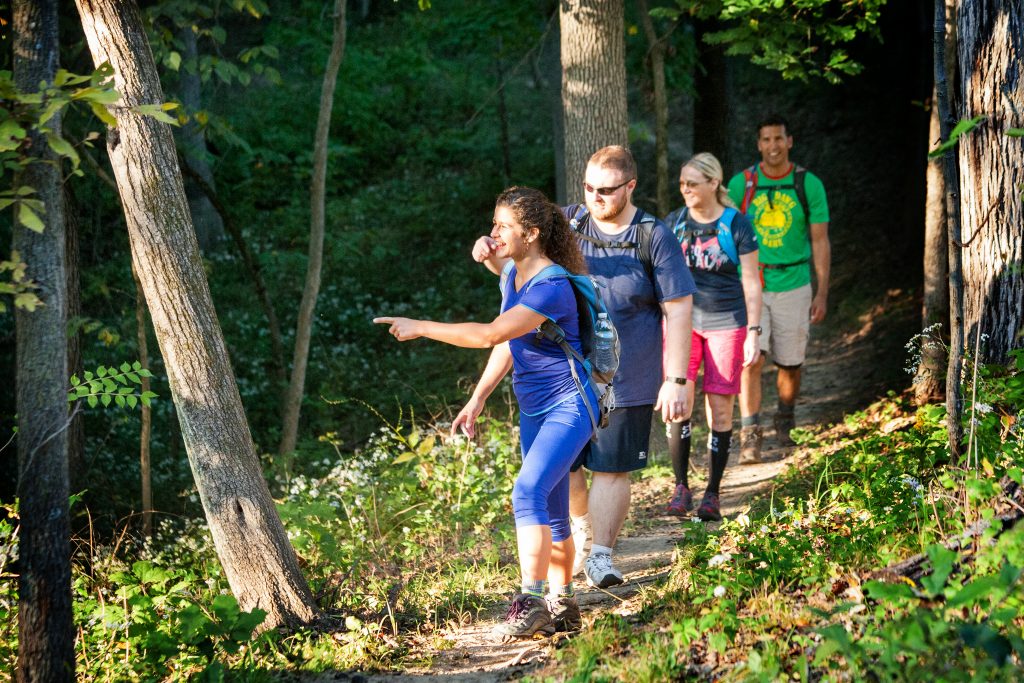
[512,387,597,543]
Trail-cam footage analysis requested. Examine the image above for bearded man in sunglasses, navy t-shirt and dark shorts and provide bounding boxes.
[473,145,696,588]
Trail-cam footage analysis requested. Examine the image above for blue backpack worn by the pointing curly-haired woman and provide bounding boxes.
[499,261,620,438]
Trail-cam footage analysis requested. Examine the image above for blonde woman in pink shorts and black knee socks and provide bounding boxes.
[665,153,761,520]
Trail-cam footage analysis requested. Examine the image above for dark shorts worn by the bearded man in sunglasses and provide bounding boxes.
[572,404,654,473]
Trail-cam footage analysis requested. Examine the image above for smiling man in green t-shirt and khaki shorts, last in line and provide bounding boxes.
[729,116,831,463]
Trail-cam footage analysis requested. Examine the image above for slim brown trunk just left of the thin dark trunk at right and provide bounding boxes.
[913,95,949,405]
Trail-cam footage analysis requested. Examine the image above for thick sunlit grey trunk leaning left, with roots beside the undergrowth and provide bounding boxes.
[76,0,318,628]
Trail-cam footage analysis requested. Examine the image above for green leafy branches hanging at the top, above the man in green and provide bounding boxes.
[651,0,886,83]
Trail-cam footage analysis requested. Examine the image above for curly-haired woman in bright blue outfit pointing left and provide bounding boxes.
[374,187,597,640]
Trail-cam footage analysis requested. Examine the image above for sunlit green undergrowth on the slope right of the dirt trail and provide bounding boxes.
[561,351,1024,681]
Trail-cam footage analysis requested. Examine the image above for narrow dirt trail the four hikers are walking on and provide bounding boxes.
[316,311,905,683]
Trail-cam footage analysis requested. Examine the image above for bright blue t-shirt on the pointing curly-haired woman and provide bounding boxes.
[502,265,587,415]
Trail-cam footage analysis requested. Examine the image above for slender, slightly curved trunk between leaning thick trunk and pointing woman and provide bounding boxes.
[278,0,345,454]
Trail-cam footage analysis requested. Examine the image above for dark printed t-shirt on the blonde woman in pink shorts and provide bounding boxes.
[665,207,758,331]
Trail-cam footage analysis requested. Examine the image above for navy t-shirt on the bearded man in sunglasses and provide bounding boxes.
[562,206,696,408]
